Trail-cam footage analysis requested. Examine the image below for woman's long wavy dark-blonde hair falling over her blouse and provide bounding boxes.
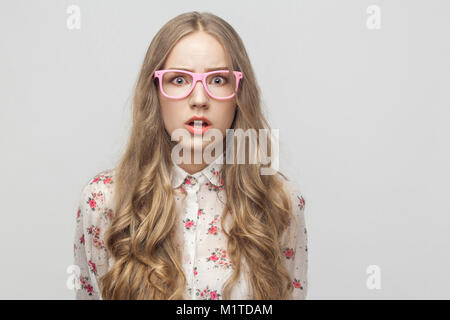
[99,11,292,300]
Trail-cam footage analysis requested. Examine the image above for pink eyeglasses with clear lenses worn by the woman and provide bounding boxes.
[153,69,244,100]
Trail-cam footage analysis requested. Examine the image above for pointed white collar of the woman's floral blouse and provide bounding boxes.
[172,153,224,188]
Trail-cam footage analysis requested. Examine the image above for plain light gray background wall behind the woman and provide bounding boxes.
[0,0,450,299]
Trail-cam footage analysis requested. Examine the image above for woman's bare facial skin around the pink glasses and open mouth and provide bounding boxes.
[158,32,236,159]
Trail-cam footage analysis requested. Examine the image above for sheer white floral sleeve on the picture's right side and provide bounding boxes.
[282,182,308,300]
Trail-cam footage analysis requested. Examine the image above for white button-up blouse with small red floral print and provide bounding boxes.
[73,155,308,300]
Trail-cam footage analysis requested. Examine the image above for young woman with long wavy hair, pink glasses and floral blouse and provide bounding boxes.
[74,12,308,300]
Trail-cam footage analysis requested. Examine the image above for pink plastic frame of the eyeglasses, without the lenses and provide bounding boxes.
[153,69,244,100]
